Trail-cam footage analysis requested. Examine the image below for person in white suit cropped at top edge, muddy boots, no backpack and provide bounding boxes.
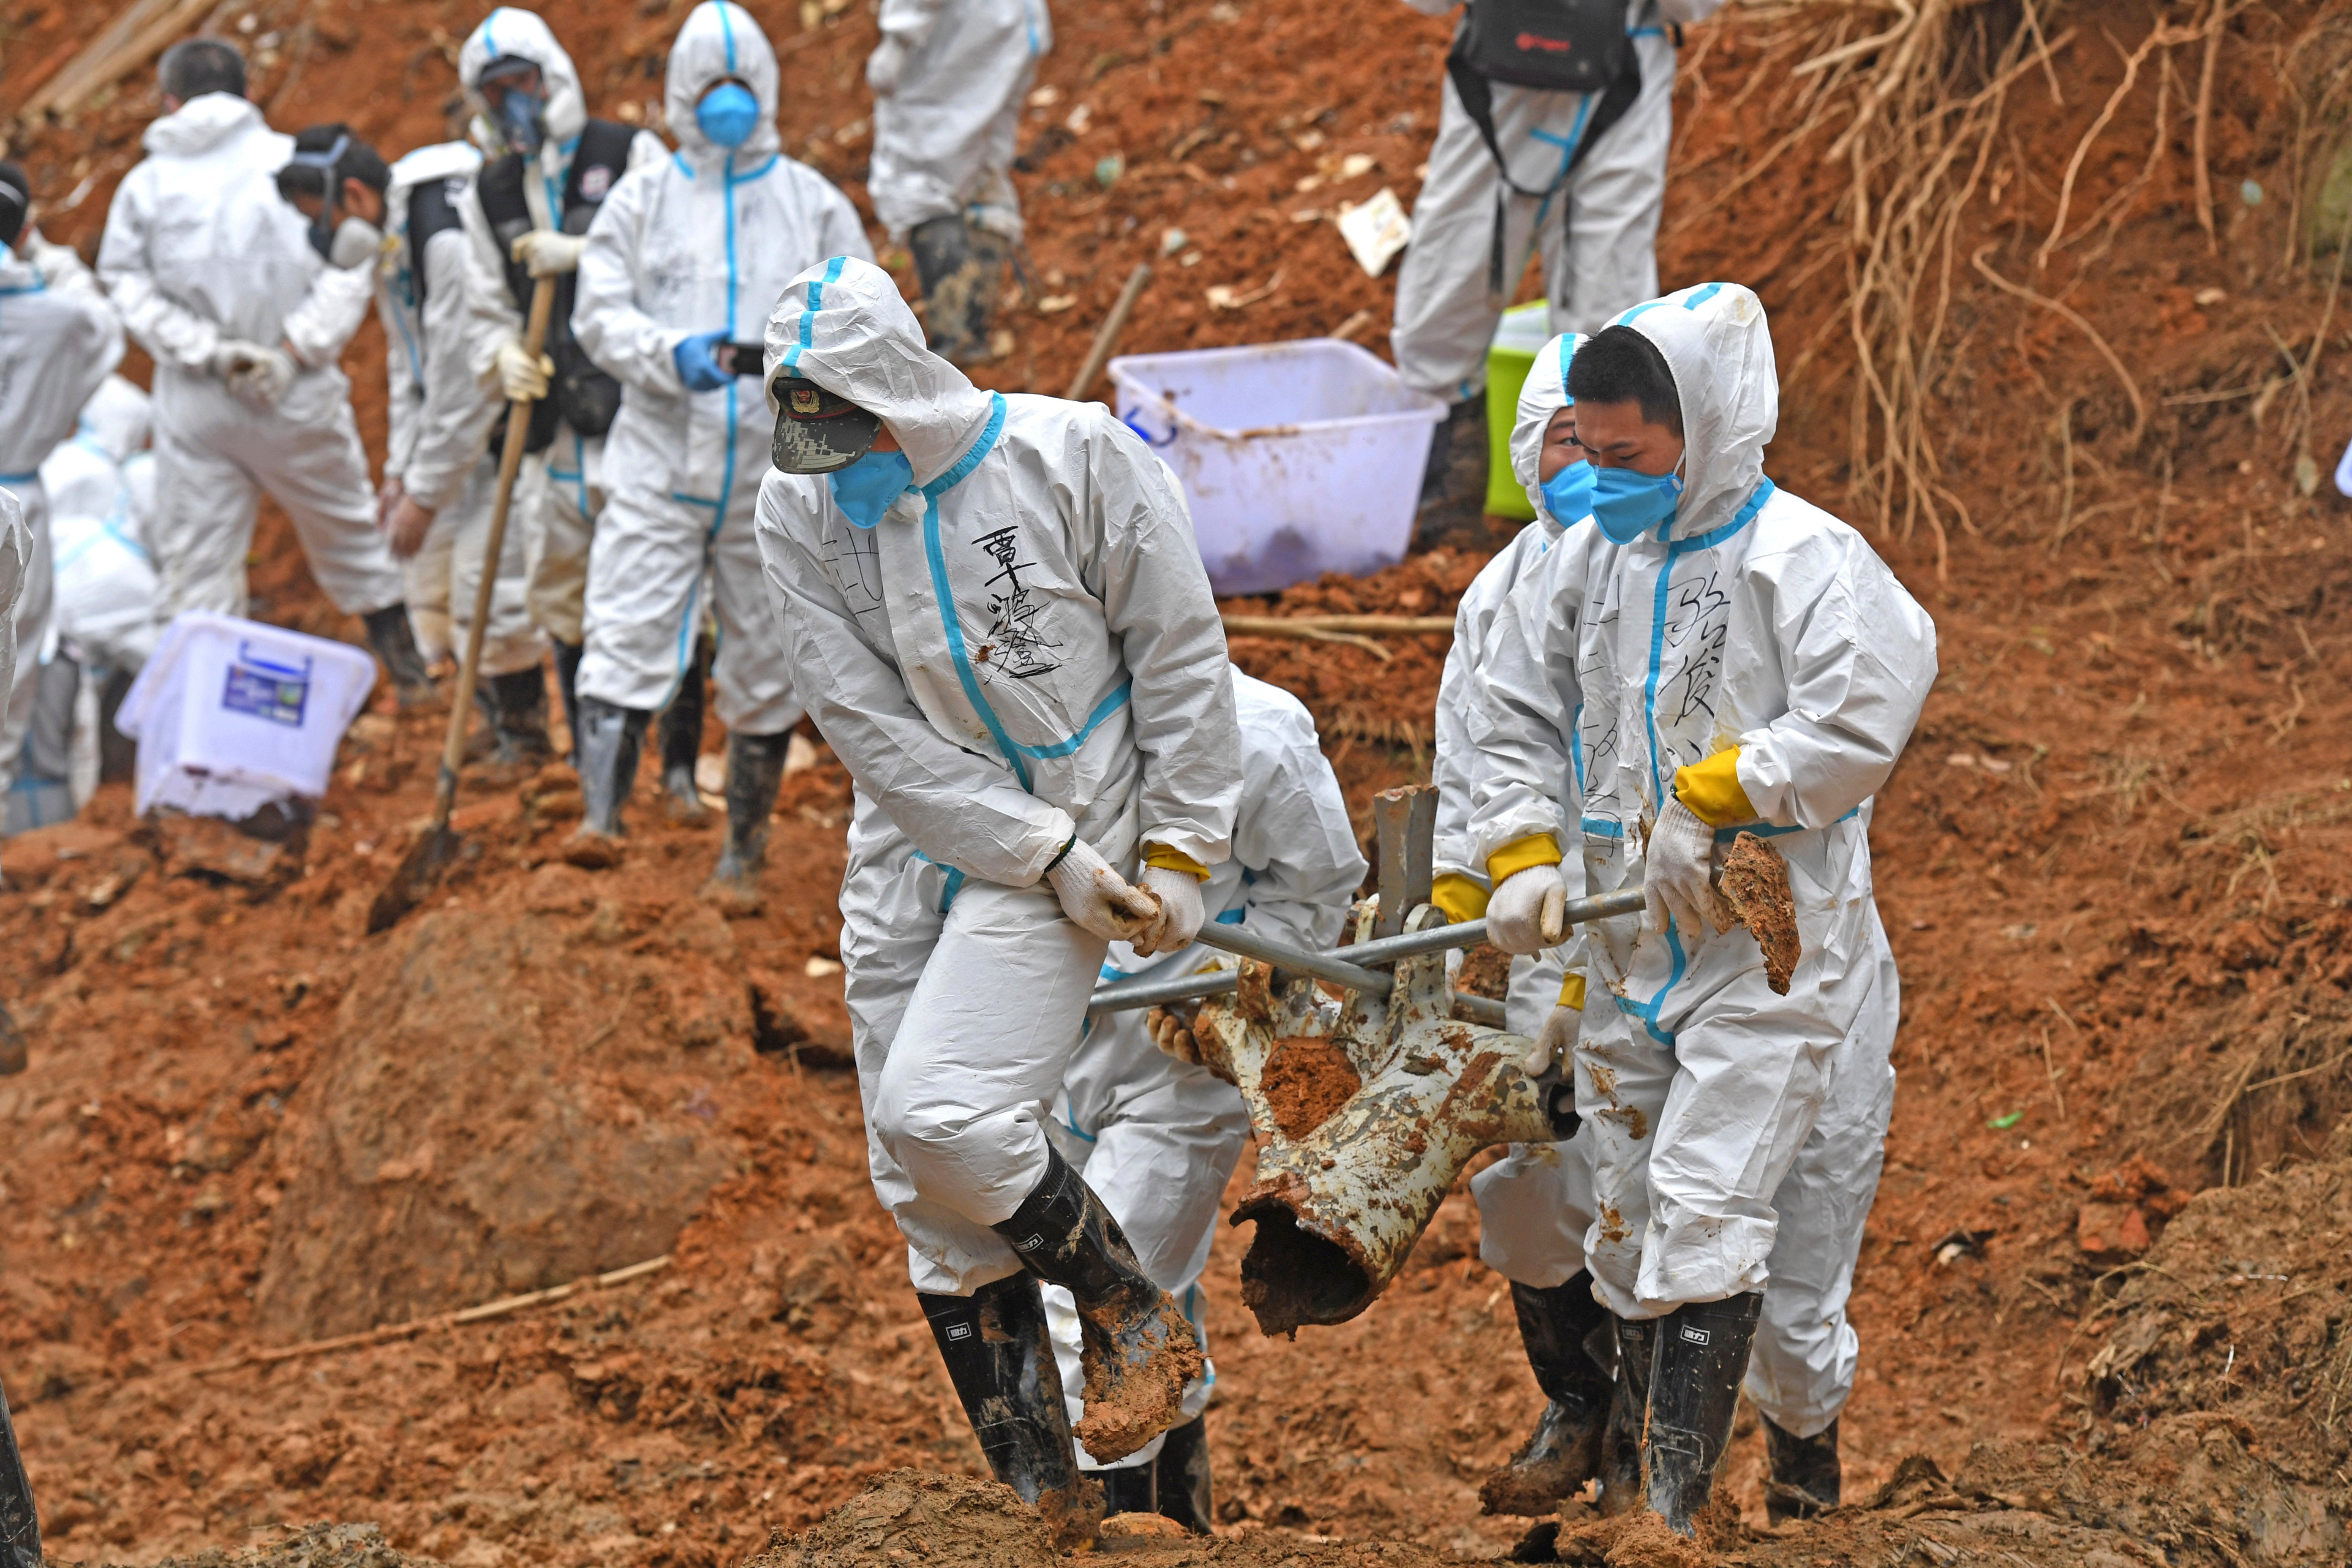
[866,0,1054,365]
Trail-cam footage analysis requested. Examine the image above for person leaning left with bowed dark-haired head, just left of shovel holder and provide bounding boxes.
[294,125,555,769]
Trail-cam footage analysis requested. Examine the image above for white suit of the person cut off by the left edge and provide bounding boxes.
[0,233,122,808]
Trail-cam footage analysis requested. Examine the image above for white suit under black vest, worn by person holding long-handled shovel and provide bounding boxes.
[456,5,670,644]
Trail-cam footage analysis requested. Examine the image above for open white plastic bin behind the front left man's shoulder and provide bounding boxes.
[1110,338,1446,595]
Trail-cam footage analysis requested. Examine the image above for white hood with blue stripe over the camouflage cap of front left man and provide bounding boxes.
[767,256,995,484]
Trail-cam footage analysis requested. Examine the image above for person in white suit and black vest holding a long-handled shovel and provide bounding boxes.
[456,5,670,752]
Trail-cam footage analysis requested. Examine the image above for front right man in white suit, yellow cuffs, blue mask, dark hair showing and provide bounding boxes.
[1473,284,1936,1533]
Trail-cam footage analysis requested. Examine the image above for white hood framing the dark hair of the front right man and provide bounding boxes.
[1611,282,1780,538]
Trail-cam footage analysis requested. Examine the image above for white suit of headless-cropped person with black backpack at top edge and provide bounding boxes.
[1390,0,1722,402]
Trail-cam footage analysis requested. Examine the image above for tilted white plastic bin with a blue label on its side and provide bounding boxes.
[115,611,376,820]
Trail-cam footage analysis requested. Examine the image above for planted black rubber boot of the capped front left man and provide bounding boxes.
[915,1274,1080,1521]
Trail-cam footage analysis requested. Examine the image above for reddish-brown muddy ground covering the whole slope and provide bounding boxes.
[0,0,2352,1568]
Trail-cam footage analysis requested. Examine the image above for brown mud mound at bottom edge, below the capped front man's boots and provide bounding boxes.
[752,1469,1059,1568]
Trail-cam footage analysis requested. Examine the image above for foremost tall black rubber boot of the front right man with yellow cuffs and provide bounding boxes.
[1642,1290,1764,1535]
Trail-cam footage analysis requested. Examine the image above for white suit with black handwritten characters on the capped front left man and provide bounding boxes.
[760,256,1242,1295]
